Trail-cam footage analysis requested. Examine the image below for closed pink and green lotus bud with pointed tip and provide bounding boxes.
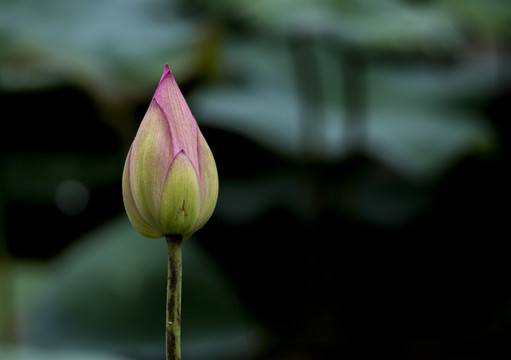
[122,65,218,240]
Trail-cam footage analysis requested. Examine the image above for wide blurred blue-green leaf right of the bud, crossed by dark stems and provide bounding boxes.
[191,43,495,178]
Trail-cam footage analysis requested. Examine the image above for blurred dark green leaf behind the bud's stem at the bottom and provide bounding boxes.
[26,217,259,359]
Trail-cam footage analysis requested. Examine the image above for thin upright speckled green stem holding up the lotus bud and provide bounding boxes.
[166,235,183,360]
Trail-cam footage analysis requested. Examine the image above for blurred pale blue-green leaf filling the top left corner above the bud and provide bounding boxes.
[0,0,200,97]
